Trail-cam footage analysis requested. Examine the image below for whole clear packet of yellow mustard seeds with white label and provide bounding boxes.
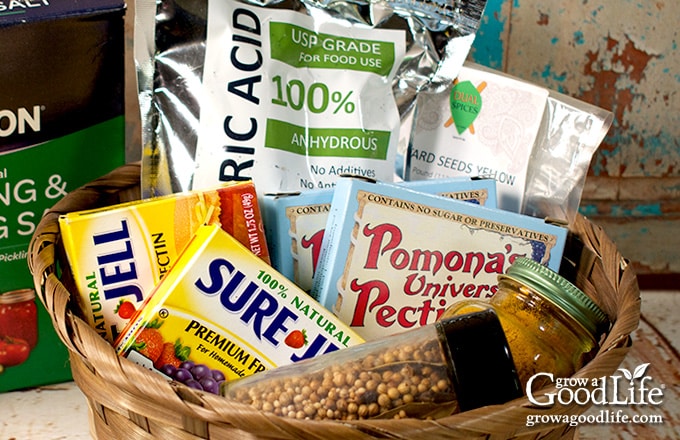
[404,62,613,223]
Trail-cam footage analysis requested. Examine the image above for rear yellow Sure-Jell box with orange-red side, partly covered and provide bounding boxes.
[59,181,269,343]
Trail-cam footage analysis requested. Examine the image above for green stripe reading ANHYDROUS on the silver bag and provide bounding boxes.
[265,119,390,160]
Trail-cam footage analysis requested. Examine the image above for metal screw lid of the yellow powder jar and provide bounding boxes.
[498,257,609,340]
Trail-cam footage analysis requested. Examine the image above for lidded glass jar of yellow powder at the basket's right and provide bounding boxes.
[442,258,609,390]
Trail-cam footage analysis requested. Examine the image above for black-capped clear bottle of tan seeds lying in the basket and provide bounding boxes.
[222,310,523,420]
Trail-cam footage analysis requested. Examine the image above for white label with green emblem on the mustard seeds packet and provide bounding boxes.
[405,63,548,212]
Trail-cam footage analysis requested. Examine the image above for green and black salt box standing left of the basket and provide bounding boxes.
[0,0,126,392]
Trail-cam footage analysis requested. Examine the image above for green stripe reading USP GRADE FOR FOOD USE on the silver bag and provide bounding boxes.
[269,22,395,76]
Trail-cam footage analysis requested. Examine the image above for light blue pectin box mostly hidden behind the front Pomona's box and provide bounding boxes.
[260,177,496,292]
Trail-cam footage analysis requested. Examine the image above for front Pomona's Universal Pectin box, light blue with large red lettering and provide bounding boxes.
[312,178,567,340]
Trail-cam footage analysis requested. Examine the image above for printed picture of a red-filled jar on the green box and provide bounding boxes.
[0,289,38,348]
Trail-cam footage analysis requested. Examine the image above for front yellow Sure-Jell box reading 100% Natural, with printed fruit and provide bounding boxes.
[115,225,364,393]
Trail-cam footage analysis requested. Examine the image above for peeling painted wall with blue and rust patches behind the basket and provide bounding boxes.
[471,0,680,273]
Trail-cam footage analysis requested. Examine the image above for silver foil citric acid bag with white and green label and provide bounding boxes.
[136,0,486,196]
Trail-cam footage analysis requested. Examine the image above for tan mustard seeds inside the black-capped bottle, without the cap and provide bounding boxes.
[225,312,520,420]
